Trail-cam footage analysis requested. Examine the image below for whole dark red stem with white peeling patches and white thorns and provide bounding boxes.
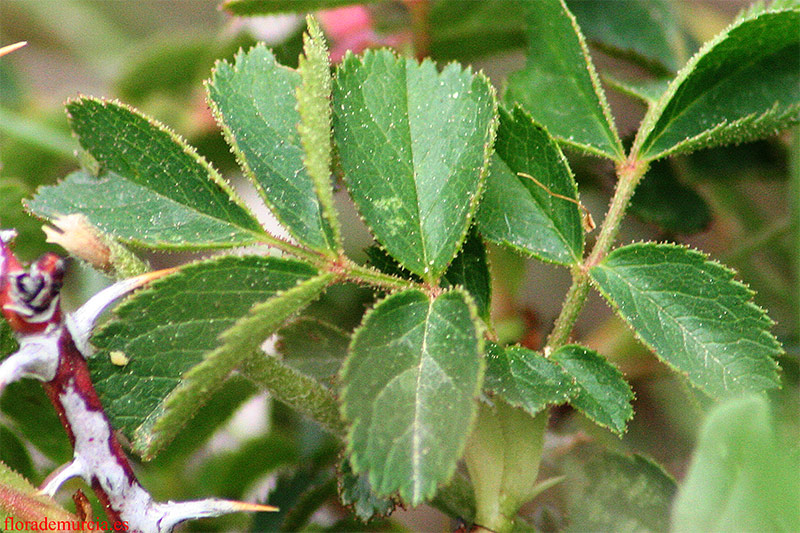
[0,230,277,533]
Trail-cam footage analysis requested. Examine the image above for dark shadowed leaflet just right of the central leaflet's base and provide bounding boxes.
[442,230,492,321]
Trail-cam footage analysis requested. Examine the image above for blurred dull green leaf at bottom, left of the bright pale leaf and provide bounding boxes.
[567,452,676,533]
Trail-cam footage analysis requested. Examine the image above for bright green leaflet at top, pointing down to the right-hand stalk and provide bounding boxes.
[505,0,624,160]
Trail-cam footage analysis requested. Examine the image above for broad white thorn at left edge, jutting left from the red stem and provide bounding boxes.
[0,328,61,394]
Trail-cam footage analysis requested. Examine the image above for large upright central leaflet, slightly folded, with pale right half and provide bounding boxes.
[333,50,495,282]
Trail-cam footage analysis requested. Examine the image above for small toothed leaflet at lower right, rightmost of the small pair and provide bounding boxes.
[550,344,633,435]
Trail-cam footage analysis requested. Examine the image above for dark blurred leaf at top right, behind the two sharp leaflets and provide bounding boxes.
[567,0,685,73]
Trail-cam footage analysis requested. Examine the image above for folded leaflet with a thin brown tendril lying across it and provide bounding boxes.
[476,107,583,264]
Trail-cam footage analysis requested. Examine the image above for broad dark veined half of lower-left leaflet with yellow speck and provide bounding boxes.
[89,256,317,452]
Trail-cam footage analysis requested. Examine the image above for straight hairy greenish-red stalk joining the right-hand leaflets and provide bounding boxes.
[544,155,648,355]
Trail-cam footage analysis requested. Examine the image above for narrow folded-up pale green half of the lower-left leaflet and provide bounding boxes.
[147,274,334,457]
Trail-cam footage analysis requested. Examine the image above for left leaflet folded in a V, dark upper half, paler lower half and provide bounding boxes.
[58,98,263,249]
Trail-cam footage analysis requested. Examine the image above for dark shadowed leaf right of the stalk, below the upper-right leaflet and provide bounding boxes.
[629,161,711,235]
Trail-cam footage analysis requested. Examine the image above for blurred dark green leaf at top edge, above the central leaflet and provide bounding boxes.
[428,0,525,61]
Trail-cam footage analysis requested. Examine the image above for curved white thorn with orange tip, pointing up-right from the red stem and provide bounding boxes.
[65,268,175,357]
